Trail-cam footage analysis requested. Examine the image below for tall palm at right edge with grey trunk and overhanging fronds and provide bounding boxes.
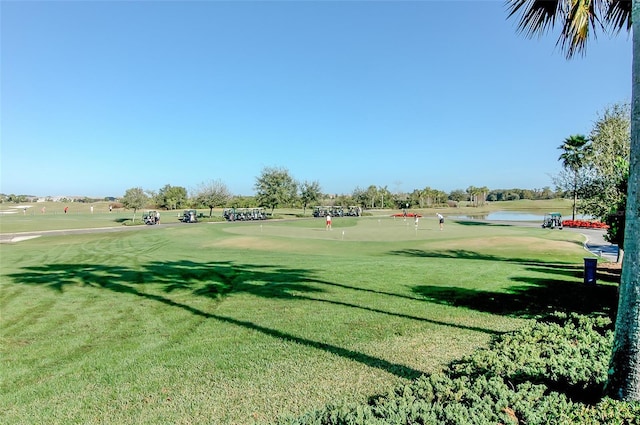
[506,0,640,401]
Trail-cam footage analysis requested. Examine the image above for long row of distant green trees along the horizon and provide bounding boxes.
[119,174,567,219]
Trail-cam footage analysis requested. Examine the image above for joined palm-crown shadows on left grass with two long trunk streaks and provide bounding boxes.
[9,261,494,379]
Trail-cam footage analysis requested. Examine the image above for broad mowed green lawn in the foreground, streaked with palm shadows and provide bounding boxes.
[0,216,614,424]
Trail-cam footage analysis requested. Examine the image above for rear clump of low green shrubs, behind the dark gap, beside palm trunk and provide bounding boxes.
[449,315,613,402]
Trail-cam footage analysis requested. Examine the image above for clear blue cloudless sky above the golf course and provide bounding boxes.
[0,0,632,197]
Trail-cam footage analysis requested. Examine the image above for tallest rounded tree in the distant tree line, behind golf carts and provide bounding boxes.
[255,167,298,214]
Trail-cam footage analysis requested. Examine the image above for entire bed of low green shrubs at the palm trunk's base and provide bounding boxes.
[279,314,640,425]
